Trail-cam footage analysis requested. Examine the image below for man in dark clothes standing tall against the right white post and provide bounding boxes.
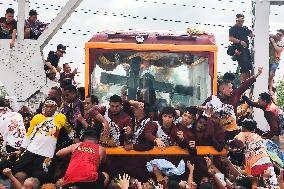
[229,14,253,82]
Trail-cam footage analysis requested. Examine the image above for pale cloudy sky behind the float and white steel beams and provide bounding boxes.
[0,0,284,86]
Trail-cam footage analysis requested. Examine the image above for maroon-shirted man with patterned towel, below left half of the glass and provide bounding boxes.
[97,95,132,146]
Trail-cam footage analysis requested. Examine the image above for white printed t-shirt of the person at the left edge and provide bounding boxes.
[0,108,26,149]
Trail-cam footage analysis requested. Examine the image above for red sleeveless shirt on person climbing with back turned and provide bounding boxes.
[64,142,100,185]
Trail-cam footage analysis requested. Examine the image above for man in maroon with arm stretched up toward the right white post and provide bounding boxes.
[203,67,262,115]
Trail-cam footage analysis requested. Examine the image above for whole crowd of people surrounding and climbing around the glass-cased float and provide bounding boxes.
[0,8,284,189]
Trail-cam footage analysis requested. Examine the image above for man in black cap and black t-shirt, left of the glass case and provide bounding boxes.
[44,44,66,80]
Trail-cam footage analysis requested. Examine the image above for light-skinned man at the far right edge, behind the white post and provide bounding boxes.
[268,29,284,95]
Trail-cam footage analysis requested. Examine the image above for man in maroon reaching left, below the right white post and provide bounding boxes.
[243,93,280,139]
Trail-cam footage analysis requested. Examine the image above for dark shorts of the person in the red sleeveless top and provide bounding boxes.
[63,172,106,189]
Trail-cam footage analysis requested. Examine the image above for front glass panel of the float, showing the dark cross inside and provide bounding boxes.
[92,51,211,109]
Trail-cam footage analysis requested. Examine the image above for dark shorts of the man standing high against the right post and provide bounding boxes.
[237,48,252,73]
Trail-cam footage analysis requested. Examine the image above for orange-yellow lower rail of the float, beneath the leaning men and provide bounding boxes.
[106,146,227,156]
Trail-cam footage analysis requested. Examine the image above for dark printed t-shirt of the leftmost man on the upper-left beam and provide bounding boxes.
[0,17,17,39]
